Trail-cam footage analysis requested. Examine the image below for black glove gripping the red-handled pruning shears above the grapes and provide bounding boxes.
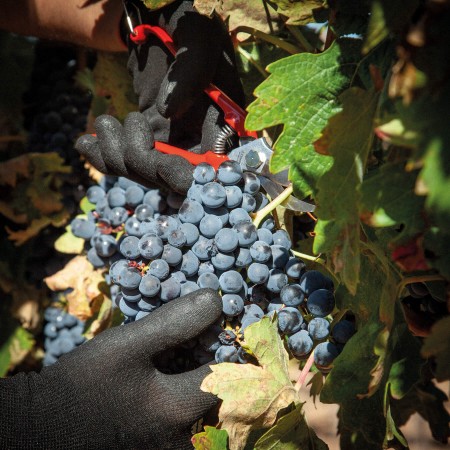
[75,0,244,194]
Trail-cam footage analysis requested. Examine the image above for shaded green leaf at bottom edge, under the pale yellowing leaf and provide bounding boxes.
[254,404,328,450]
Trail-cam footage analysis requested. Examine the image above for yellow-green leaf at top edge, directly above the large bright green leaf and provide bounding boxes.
[267,0,326,25]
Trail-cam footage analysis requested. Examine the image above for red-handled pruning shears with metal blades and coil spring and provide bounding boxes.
[123,1,315,212]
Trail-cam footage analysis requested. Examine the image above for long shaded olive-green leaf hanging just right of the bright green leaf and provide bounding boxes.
[313,87,378,294]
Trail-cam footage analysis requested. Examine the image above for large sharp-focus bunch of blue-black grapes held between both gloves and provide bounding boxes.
[72,161,355,371]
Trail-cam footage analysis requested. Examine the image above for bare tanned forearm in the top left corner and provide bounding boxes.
[0,0,126,51]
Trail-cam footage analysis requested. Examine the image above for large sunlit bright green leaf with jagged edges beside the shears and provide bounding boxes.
[246,39,360,196]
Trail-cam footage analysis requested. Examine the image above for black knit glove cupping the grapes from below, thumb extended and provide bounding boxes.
[0,289,222,450]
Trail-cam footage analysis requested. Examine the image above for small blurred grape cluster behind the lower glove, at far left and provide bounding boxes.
[42,306,86,366]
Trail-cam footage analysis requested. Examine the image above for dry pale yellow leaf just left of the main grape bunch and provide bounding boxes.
[44,255,108,320]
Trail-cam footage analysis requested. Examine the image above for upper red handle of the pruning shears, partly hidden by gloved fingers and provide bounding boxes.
[130,24,258,139]
